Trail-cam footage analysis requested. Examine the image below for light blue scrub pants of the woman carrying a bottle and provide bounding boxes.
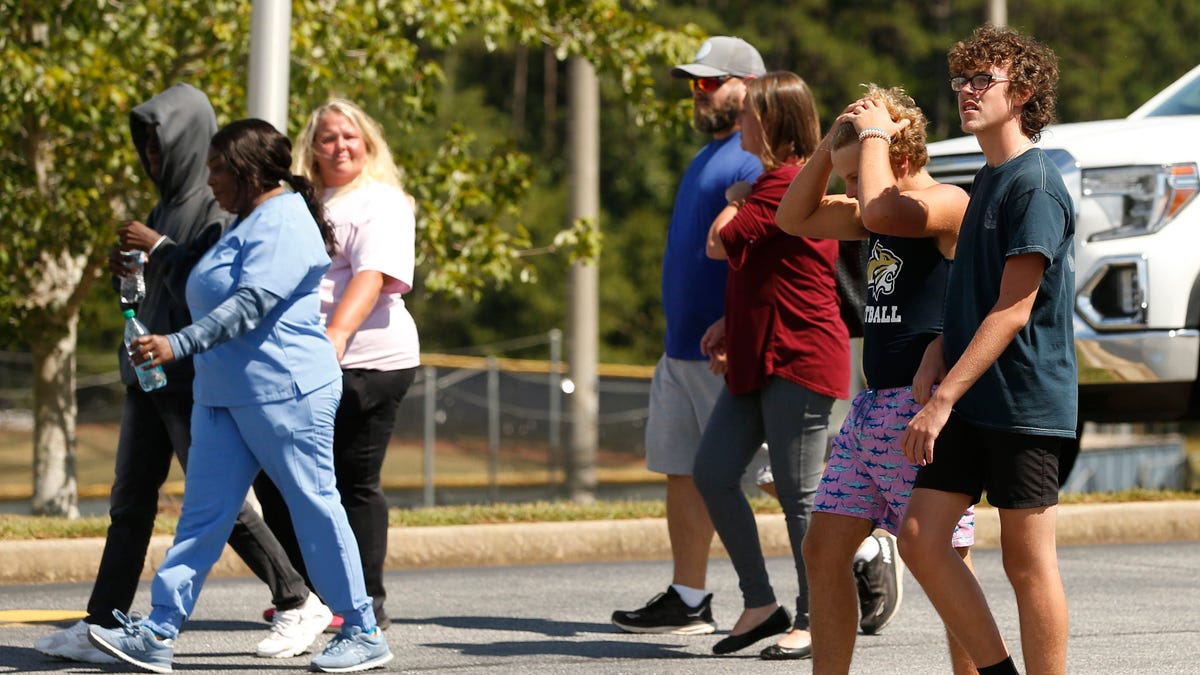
[149,378,376,638]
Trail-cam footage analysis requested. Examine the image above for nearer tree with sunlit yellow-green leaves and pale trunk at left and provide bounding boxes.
[0,0,694,514]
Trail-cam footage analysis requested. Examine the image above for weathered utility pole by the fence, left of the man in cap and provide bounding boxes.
[566,56,600,503]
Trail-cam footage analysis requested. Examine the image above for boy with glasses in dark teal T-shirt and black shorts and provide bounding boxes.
[900,26,1078,675]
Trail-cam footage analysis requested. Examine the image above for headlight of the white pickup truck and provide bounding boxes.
[1082,162,1200,241]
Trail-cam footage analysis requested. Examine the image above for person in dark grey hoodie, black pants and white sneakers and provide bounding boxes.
[35,84,331,663]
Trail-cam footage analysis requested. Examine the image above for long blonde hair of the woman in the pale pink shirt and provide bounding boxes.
[292,98,408,195]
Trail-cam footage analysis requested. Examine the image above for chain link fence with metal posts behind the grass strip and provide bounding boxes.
[0,330,661,506]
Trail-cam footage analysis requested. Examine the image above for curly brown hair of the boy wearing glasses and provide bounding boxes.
[947,24,1058,141]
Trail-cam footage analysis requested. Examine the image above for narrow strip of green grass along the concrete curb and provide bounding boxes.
[0,489,1200,540]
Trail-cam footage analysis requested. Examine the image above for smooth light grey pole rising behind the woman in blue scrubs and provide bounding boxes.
[246,0,292,135]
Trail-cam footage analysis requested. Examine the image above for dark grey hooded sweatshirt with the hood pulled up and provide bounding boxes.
[119,84,230,392]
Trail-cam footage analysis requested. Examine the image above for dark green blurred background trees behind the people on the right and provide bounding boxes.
[434,0,1200,363]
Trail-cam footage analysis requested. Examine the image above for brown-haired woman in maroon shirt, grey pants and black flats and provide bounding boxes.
[694,72,850,659]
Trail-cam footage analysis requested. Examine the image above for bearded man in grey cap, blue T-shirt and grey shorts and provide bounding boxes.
[612,37,767,635]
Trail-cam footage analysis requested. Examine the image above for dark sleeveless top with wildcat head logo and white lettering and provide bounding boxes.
[863,234,950,389]
